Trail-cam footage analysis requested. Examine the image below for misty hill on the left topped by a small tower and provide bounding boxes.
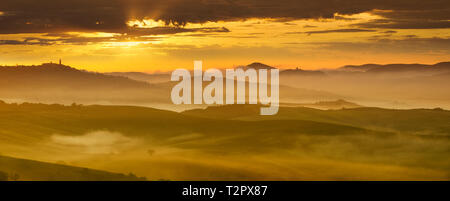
[0,63,170,104]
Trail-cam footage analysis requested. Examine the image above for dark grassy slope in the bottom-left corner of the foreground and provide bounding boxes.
[0,156,145,181]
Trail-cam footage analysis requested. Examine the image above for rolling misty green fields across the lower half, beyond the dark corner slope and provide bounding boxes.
[0,100,450,180]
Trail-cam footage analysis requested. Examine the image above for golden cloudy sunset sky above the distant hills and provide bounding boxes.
[0,0,450,72]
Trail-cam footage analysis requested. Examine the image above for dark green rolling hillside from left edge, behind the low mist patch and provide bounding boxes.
[0,104,387,150]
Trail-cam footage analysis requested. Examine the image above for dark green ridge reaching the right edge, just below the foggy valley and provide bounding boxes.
[183,105,450,136]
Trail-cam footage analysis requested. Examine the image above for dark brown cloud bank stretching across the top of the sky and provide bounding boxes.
[0,0,450,34]
